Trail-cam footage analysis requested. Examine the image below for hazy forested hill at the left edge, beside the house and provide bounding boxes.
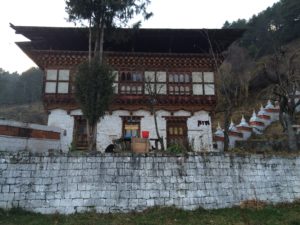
[0,68,43,105]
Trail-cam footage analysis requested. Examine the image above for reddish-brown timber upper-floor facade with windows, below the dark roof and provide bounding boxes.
[38,51,216,113]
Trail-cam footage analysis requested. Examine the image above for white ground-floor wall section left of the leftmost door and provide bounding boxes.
[48,109,74,152]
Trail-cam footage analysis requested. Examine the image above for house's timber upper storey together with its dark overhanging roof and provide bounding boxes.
[11,25,244,112]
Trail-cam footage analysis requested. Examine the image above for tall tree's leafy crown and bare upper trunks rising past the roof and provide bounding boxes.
[66,0,152,64]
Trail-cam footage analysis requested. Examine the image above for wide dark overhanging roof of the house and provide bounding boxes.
[11,24,244,53]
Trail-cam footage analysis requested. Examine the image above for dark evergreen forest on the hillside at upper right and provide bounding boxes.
[223,0,300,57]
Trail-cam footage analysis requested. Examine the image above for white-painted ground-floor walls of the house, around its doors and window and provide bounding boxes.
[48,109,213,152]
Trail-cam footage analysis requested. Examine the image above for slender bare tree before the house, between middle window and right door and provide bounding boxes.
[145,74,165,150]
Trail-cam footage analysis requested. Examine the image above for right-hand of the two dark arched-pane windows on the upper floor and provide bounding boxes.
[168,72,192,95]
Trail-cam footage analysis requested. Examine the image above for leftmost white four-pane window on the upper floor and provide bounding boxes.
[45,69,70,94]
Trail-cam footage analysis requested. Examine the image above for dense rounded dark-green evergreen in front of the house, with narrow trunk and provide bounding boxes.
[75,59,114,151]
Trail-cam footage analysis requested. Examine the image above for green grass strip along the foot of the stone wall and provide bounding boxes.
[0,203,300,225]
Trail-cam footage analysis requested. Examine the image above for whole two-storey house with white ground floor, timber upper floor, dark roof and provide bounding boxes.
[11,25,243,151]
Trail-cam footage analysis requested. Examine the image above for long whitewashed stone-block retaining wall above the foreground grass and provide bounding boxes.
[0,153,300,214]
